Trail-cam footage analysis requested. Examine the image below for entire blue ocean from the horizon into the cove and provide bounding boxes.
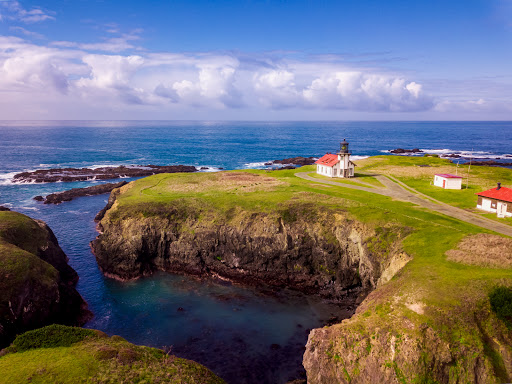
[0,121,512,383]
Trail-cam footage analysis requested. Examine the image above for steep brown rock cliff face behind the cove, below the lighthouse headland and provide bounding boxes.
[92,189,410,300]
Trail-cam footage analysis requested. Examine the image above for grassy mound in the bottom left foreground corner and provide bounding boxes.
[0,326,223,384]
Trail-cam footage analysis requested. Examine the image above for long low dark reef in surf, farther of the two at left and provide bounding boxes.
[12,165,197,183]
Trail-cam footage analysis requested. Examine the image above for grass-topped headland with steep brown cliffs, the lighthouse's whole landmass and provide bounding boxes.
[92,156,512,383]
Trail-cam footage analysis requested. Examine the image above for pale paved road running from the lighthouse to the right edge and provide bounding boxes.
[295,172,512,237]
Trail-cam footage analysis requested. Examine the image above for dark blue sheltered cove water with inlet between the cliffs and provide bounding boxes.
[13,190,355,383]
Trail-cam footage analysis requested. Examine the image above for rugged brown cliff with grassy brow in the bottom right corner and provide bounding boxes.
[303,273,512,384]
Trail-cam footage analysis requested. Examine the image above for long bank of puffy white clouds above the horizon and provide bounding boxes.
[0,35,440,116]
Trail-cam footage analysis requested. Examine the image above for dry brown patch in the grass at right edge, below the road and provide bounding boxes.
[446,233,512,268]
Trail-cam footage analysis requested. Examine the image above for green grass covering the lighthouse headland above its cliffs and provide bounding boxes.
[99,161,512,377]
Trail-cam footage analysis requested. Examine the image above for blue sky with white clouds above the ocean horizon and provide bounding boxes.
[0,0,512,120]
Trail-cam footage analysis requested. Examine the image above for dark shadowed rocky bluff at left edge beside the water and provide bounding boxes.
[0,212,91,347]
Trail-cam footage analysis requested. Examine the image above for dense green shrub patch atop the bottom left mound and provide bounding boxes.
[12,324,97,352]
